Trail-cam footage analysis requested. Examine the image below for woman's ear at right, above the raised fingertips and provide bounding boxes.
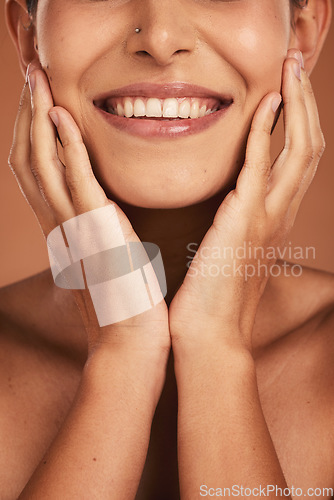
[289,0,332,75]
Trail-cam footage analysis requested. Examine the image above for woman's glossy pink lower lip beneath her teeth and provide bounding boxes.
[96,103,232,139]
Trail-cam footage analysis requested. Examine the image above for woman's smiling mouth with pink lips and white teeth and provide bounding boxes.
[93,82,233,135]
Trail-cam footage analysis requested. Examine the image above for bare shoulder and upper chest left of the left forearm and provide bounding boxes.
[0,271,82,498]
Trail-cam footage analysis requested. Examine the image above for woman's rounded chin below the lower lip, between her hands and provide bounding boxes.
[88,148,237,209]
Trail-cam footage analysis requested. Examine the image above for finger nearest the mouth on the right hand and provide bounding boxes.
[236,92,281,207]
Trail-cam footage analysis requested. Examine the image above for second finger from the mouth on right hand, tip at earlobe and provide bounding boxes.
[266,51,313,213]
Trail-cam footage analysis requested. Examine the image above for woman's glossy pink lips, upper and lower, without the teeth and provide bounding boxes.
[93,82,233,138]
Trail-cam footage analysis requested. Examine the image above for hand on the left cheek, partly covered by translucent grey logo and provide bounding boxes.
[9,62,170,360]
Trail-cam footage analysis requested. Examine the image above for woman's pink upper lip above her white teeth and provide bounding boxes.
[94,82,233,106]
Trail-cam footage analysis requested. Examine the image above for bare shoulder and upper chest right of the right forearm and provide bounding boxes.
[254,263,334,486]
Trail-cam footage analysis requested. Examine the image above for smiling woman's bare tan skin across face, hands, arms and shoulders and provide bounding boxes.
[3,0,333,500]
